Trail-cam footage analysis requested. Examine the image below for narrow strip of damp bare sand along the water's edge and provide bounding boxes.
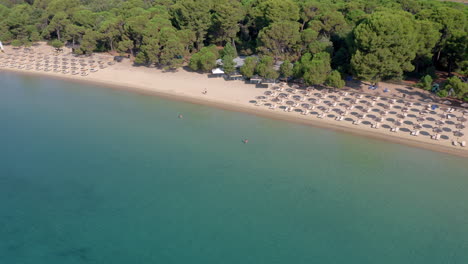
[1,68,468,158]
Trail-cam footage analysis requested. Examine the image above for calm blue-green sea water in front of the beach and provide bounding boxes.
[0,73,468,264]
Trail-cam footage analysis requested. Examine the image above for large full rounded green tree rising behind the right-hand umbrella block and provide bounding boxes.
[351,12,417,82]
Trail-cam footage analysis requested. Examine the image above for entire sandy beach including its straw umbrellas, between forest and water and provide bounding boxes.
[0,45,468,157]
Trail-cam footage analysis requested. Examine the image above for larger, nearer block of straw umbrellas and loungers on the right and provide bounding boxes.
[250,84,468,146]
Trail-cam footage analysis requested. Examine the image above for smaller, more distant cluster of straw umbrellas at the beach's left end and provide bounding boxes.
[0,50,114,76]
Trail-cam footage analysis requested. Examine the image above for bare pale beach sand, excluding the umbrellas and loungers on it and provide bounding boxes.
[0,44,468,157]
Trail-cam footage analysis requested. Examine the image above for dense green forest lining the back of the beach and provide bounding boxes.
[0,0,468,100]
